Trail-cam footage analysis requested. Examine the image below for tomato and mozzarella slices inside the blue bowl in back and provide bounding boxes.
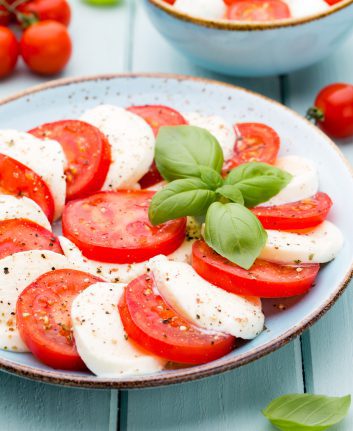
[164,0,342,22]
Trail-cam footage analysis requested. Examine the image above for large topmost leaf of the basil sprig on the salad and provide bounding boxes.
[155,126,223,181]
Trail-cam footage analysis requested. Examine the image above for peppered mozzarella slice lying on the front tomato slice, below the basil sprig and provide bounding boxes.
[149,256,264,339]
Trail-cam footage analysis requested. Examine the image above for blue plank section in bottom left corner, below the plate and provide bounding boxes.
[0,373,113,431]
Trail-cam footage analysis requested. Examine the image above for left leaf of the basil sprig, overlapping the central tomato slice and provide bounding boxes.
[148,178,217,225]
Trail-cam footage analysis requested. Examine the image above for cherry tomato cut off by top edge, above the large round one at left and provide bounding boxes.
[17,0,71,26]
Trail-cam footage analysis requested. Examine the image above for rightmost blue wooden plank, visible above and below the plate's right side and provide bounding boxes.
[286,33,353,431]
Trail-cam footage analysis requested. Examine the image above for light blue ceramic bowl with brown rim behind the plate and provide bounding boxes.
[143,0,353,76]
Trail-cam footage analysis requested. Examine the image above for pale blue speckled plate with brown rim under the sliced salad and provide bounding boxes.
[0,75,353,388]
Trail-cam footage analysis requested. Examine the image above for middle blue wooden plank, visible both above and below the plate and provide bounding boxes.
[124,4,303,431]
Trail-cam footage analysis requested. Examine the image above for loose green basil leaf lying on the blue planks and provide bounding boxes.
[262,394,351,431]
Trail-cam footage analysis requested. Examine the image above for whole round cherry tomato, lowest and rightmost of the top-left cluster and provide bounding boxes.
[21,21,72,75]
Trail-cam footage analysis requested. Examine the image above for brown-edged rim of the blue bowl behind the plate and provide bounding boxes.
[145,0,353,31]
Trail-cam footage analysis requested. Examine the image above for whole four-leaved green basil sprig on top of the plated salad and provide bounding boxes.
[149,126,292,269]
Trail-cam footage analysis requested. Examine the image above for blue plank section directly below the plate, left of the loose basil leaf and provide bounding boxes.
[122,343,303,431]
